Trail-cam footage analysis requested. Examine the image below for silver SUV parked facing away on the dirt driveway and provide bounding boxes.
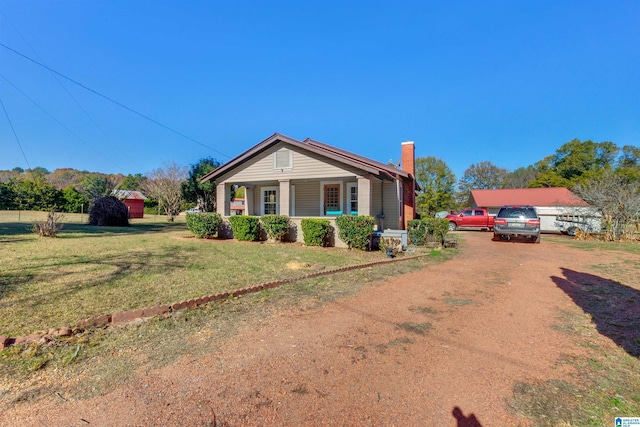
[493,206,540,243]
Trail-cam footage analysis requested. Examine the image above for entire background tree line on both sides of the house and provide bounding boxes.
[0,139,640,236]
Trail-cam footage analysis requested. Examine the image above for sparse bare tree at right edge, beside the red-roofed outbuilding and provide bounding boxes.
[574,170,640,241]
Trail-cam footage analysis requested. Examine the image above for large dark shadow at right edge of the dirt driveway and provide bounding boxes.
[551,268,640,357]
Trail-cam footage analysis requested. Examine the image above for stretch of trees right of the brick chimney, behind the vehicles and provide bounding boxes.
[415,139,640,215]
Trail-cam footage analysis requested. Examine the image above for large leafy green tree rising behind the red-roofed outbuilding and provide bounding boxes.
[530,139,619,187]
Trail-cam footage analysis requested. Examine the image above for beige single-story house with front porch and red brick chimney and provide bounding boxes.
[201,133,416,246]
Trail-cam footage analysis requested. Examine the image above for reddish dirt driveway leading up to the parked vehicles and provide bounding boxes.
[0,232,632,427]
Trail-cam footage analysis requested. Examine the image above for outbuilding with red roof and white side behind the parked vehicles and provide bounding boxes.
[471,187,600,234]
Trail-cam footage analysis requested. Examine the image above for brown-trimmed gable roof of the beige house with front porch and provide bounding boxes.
[200,132,413,182]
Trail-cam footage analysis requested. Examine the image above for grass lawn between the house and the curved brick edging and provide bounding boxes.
[0,211,430,336]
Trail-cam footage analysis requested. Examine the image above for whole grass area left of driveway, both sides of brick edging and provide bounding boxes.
[0,211,456,410]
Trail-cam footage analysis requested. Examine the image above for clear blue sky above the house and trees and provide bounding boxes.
[0,0,640,178]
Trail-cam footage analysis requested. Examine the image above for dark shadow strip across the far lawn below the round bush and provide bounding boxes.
[0,222,187,239]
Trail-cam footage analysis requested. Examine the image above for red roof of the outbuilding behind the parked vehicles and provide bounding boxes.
[471,187,589,207]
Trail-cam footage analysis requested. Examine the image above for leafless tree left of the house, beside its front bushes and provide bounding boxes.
[142,162,188,222]
